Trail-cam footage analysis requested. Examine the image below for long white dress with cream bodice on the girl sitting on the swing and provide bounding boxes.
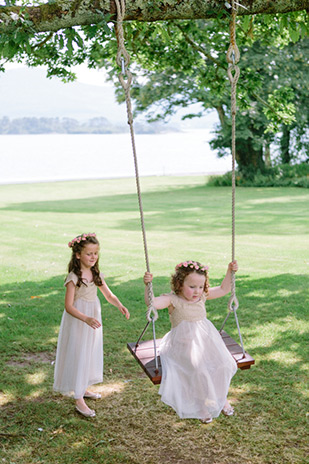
[159,293,237,419]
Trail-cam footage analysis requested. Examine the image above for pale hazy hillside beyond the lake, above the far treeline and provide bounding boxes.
[0,67,218,129]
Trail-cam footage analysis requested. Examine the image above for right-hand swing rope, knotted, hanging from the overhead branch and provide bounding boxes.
[219,0,245,357]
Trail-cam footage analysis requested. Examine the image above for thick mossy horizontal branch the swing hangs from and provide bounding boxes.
[0,0,309,33]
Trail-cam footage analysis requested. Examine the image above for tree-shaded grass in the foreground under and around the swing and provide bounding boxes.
[0,274,308,464]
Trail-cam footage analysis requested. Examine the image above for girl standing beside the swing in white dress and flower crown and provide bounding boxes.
[53,233,130,417]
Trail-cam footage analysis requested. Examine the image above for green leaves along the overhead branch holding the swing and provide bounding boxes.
[0,0,309,80]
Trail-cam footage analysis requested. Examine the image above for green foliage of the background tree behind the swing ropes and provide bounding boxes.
[100,16,309,173]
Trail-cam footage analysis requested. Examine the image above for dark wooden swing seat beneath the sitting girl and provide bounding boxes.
[127,331,255,385]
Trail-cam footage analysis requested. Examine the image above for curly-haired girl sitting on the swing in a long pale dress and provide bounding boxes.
[144,261,238,423]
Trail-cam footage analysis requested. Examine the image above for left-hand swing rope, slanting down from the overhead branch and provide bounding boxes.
[115,0,158,328]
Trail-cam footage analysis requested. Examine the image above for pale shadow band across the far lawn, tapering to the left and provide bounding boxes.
[2,186,308,235]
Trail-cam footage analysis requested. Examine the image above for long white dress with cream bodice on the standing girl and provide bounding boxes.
[53,272,103,399]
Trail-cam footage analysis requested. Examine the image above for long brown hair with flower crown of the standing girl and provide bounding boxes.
[68,234,103,287]
